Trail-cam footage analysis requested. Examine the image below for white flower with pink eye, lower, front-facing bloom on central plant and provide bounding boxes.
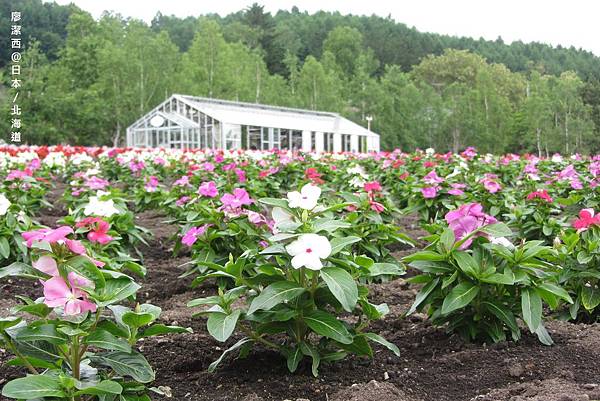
[285,234,331,270]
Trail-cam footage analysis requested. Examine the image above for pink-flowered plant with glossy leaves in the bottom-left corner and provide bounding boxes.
[0,226,190,401]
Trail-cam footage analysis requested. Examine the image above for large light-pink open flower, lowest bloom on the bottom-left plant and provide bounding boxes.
[42,272,96,316]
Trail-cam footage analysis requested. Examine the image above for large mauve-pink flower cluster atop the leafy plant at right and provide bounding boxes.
[445,203,497,250]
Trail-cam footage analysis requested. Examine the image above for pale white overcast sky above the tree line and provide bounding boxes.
[51,0,600,56]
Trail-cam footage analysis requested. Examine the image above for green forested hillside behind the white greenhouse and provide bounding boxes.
[0,0,600,155]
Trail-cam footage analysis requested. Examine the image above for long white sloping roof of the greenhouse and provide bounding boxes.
[174,95,378,136]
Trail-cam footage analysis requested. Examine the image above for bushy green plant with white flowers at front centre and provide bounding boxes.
[188,184,399,376]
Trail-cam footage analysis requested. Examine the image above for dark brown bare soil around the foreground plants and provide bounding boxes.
[0,195,600,401]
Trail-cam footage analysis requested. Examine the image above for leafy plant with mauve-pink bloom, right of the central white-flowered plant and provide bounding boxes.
[404,203,573,345]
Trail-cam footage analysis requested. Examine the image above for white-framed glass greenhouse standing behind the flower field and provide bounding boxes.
[127,94,379,153]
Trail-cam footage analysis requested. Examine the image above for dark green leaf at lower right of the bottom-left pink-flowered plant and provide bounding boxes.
[90,351,154,383]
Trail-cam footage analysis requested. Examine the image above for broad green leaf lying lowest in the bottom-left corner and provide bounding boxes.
[2,375,66,400]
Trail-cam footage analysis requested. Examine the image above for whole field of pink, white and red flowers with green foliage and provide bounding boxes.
[0,146,600,401]
